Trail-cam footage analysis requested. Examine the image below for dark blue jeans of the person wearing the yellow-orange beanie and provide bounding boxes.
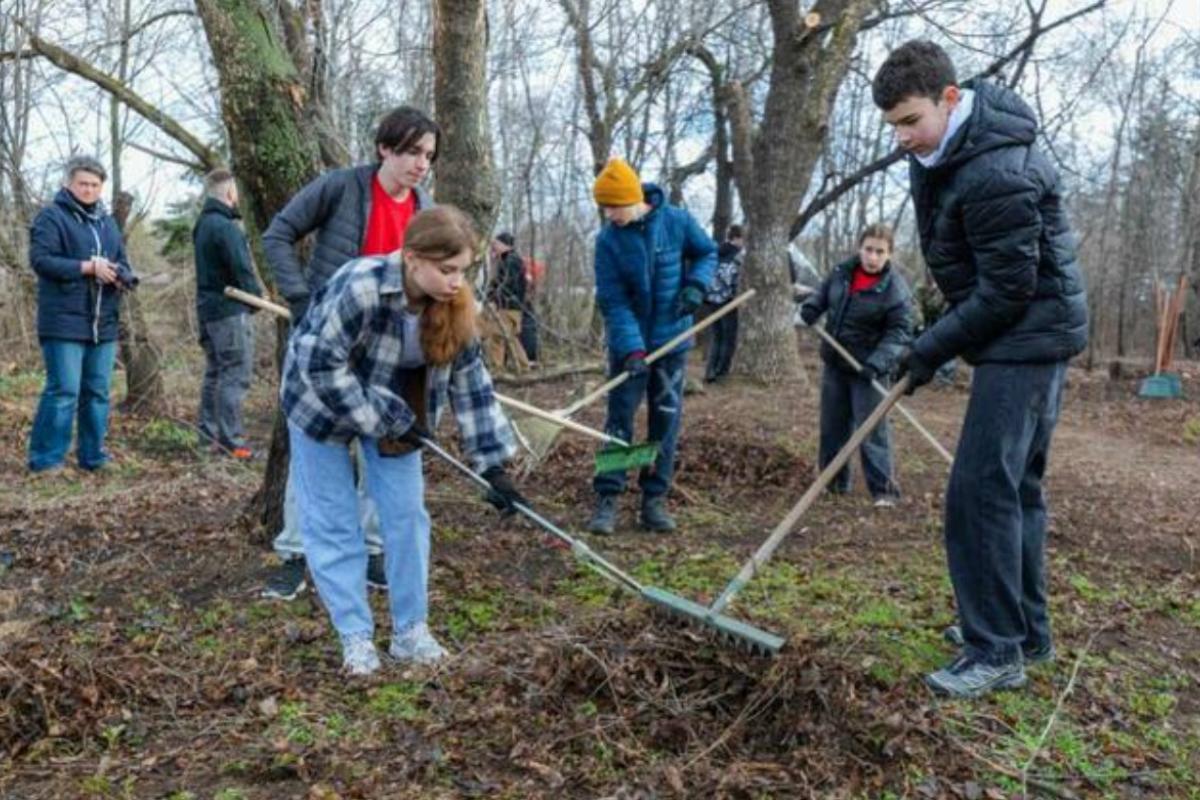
[592,350,688,498]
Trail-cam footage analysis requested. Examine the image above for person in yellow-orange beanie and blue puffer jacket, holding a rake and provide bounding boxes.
[588,158,716,535]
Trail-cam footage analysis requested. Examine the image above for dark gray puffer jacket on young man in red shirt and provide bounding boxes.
[263,164,433,308]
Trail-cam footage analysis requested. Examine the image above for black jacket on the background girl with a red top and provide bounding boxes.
[800,255,912,374]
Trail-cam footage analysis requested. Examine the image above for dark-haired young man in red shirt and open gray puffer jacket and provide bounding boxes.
[263,106,440,600]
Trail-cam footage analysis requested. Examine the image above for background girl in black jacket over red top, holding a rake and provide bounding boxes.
[800,224,912,507]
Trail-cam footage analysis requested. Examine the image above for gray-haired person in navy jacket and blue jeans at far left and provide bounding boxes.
[29,156,137,473]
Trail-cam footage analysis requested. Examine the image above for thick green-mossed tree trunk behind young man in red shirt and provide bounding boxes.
[196,0,320,541]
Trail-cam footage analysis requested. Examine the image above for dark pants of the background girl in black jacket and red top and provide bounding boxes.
[820,363,900,498]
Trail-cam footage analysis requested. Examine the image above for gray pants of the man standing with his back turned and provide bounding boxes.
[199,314,254,447]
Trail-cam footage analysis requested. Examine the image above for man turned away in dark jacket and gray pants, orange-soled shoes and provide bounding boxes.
[192,169,263,461]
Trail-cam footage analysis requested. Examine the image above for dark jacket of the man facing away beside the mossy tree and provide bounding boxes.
[192,197,263,323]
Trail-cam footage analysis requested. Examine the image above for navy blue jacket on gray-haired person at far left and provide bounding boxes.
[29,188,137,342]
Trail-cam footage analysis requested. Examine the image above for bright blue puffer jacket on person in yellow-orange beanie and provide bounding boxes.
[595,184,716,361]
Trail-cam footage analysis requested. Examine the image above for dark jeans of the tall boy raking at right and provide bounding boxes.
[946,362,1067,664]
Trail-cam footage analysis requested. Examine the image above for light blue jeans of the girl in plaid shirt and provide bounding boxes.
[288,425,430,643]
